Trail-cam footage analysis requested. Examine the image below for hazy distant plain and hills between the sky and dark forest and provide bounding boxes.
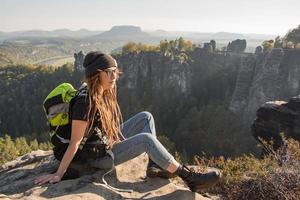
[0,25,275,66]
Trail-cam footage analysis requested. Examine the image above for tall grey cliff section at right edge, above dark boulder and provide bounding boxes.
[229,49,300,119]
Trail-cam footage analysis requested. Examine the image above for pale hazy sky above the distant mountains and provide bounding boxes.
[0,0,300,35]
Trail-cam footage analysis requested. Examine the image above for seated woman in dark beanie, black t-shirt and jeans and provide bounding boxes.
[35,52,220,191]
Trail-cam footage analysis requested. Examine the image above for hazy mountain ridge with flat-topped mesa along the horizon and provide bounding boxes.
[0,25,276,41]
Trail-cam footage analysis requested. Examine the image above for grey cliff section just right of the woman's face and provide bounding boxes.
[118,52,192,95]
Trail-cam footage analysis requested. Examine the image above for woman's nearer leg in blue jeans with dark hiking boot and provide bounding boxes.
[89,133,221,192]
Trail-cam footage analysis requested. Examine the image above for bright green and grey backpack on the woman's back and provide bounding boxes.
[43,83,78,137]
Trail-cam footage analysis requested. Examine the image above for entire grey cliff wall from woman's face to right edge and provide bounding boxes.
[118,49,300,125]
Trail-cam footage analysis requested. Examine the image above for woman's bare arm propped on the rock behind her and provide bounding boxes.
[35,120,87,185]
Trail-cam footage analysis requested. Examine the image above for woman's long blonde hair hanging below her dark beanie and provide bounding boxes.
[86,72,123,147]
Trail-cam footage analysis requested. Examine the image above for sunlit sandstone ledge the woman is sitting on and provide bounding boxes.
[0,151,218,200]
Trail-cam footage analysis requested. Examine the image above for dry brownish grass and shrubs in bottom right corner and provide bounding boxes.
[195,139,300,200]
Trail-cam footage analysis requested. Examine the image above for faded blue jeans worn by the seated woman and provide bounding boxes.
[89,112,174,169]
